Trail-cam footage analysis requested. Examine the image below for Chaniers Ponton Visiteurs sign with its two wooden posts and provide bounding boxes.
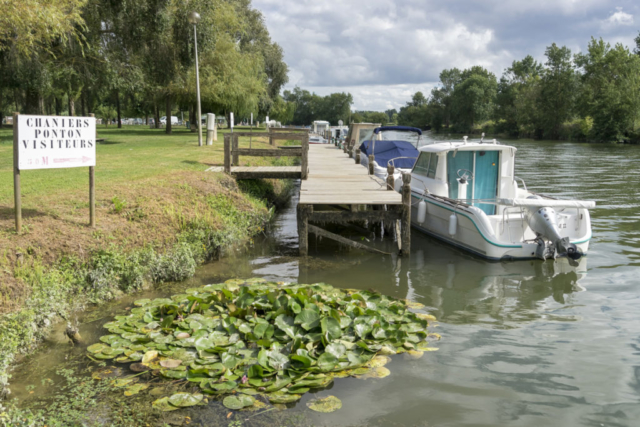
[13,113,97,233]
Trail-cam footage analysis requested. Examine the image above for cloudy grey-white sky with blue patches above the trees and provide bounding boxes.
[253,0,640,111]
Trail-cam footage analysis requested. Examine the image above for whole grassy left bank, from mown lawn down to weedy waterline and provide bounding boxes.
[0,127,296,400]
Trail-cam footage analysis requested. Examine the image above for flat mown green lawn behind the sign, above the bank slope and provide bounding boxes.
[0,125,280,208]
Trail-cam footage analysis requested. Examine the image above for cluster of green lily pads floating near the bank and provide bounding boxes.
[87,279,438,411]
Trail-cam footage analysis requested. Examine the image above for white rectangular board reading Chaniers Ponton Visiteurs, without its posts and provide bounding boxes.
[18,114,96,170]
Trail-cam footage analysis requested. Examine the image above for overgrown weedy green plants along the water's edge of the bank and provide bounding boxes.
[0,175,292,402]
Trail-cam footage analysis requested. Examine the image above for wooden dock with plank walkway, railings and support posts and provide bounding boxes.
[224,127,411,256]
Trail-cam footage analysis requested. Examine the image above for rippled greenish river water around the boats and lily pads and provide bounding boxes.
[8,140,640,426]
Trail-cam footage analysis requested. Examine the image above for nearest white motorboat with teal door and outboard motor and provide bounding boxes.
[396,137,595,260]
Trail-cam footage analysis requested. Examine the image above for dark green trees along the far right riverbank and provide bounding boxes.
[398,35,640,142]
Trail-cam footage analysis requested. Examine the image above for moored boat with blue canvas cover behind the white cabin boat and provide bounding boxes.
[359,126,422,190]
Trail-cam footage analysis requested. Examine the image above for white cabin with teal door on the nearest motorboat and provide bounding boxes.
[411,141,518,215]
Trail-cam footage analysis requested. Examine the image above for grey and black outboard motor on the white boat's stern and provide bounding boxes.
[525,196,582,260]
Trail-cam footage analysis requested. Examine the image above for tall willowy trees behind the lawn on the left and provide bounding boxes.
[0,0,288,133]
